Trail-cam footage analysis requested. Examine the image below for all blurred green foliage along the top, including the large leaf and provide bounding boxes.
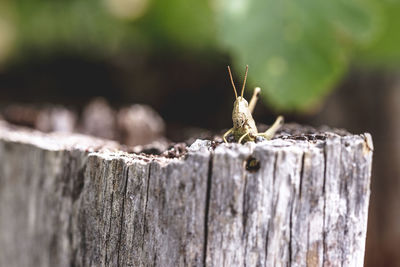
[0,0,400,111]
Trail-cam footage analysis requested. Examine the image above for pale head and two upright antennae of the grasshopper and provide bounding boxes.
[228,66,251,128]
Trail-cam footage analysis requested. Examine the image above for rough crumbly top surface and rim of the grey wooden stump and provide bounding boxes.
[0,121,373,163]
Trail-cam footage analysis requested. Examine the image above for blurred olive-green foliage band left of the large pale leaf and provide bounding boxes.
[10,0,215,55]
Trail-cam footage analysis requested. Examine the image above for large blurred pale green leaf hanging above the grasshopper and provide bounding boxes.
[216,0,379,110]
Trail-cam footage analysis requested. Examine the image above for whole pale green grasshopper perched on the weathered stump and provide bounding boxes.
[223,66,283,143]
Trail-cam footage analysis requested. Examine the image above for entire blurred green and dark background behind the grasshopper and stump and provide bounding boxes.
[0,0,400,266]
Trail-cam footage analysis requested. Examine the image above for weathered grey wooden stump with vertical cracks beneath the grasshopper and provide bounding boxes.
[0,121,373,266]
